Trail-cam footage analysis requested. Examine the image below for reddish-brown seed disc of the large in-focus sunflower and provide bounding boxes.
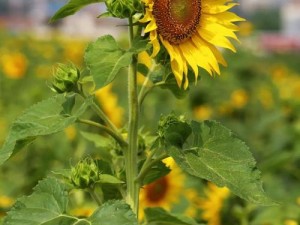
[153,0,201,44]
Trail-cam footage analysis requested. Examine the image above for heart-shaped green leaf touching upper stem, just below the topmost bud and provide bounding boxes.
[84,35,134,88]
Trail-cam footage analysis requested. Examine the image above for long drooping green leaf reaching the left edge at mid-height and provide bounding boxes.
[0,95,88,165]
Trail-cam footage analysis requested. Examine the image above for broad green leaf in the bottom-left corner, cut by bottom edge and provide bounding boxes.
[3,178,90,225]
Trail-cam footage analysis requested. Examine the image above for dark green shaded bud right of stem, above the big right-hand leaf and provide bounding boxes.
[158,114,192,148]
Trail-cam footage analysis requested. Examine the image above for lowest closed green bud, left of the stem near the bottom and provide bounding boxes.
[71,158,100,189]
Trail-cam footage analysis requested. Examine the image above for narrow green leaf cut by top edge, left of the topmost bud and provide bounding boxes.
[50,0,104,22]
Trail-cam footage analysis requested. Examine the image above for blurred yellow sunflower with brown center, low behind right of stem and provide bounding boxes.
[139,157,185,219]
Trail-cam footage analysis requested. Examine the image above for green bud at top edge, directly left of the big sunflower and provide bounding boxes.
[105,0,143,18]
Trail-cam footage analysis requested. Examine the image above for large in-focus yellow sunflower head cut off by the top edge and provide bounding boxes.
[140,0,244,89]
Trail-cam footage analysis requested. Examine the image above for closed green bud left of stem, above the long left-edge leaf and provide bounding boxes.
[52,64,80,93]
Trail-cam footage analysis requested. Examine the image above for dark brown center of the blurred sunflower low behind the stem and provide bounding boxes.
[146,177,170,203]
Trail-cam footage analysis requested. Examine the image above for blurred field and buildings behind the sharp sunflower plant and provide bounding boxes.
[0,0,300,225]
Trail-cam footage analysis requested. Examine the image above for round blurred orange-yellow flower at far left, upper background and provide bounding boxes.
[1,52,28,79]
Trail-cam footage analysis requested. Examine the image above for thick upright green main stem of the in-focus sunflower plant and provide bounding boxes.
[125,15,140,216]
